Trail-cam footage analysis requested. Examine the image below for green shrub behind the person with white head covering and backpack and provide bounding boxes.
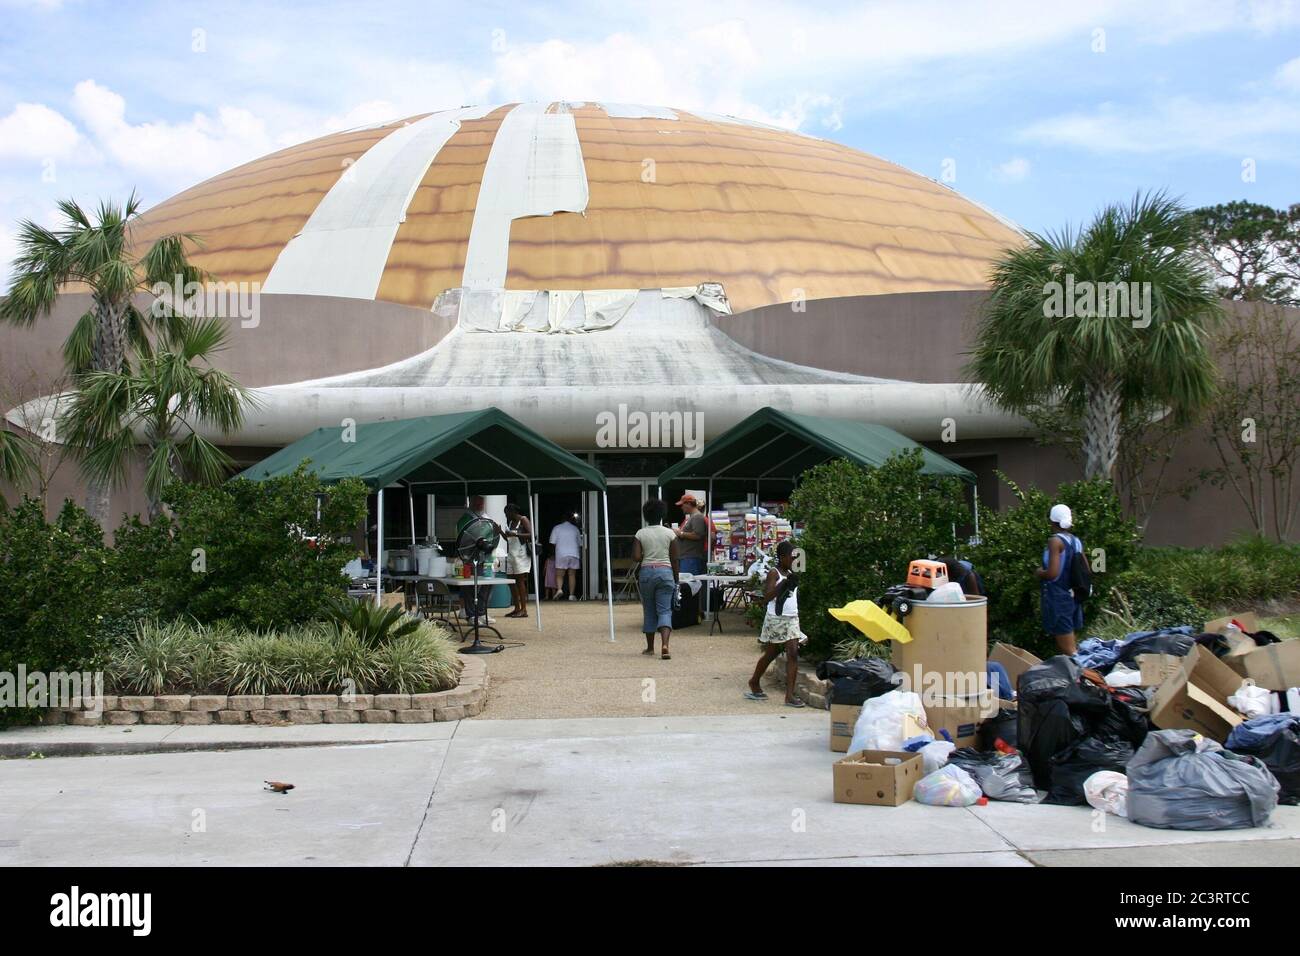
[969,476,1139,657]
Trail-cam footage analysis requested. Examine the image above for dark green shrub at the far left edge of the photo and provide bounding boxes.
[0,498,112,724]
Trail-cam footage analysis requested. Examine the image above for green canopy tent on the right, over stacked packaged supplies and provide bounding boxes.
[659,406,979,556]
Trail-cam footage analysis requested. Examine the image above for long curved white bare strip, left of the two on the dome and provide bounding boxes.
[261,105,495,299]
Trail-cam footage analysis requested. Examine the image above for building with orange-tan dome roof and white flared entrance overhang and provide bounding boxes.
[4,103,1258,561]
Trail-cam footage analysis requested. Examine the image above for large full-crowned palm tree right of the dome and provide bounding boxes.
[966,193,1222,479]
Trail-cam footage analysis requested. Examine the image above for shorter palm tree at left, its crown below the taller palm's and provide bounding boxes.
[62,316,251,518]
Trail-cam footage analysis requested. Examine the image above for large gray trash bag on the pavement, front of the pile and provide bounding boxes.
[1127,730,1279,830]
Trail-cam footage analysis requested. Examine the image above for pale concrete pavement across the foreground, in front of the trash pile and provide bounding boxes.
[0,710,1300,866]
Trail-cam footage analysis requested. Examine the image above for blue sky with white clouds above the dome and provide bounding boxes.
[0,0,1300,278]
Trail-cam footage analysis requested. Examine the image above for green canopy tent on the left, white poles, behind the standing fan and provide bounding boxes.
[238,408,614,641]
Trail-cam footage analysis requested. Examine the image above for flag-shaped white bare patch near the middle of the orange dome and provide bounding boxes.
[462,103,589,289]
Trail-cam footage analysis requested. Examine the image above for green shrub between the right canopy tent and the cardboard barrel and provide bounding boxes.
[789,450,967,657]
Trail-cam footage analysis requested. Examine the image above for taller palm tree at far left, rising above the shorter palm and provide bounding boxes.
[0,193,207,525]
